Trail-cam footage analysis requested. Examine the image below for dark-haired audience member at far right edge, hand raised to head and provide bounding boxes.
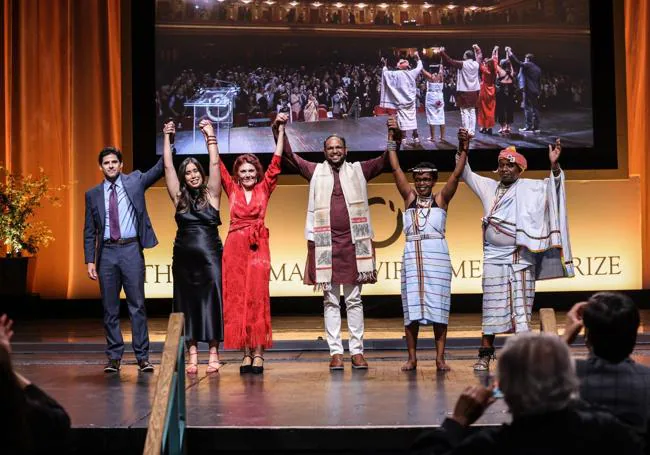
[564,292,650,453]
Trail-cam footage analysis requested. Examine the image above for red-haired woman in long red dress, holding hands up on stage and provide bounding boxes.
[219,126,284,374]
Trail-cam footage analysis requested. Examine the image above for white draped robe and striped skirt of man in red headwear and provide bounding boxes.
[463,165,573,335]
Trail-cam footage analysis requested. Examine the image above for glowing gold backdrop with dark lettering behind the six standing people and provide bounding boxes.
[139,178,641,297]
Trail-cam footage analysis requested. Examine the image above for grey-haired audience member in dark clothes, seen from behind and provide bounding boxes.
[413,332,642,455]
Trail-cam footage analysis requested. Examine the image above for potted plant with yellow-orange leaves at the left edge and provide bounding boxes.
[0,165,65,296]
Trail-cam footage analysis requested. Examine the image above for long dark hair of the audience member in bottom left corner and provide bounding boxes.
[0,345,31,453]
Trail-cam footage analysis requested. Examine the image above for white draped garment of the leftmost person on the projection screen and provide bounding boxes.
[379,60,422,131]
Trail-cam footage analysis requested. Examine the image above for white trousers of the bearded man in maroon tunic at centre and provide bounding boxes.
[323,283,363,355]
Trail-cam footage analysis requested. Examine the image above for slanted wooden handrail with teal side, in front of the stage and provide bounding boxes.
[144,313,186,455]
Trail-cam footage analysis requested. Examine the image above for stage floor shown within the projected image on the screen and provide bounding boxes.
[156,108,593,155]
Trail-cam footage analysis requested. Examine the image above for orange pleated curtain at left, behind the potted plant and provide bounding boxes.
[2,0,124,298]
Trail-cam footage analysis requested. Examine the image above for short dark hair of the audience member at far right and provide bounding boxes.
[583,292,640,363]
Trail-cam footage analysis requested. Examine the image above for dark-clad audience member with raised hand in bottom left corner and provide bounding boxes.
[0,315,70,455]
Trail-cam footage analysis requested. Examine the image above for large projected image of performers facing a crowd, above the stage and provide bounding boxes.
[156,3,594,155]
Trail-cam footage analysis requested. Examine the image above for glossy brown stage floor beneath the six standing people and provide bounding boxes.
[14,310,650,455]
